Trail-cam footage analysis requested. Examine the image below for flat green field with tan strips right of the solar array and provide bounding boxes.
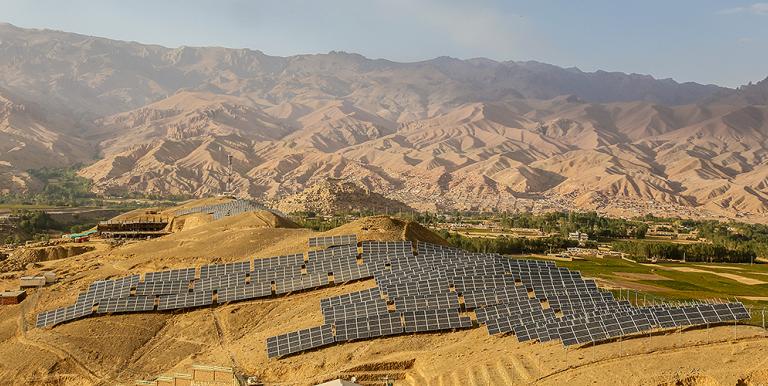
[520,257,768,325]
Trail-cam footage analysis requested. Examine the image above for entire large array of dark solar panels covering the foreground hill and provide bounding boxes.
[36,236,750,357]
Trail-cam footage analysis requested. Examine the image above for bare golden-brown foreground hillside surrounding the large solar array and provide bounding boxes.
[0,211,768,385]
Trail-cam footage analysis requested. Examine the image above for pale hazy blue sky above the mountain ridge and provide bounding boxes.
[0,0,768,87]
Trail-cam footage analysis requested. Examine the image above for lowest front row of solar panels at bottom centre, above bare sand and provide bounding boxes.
[267,309,472,358]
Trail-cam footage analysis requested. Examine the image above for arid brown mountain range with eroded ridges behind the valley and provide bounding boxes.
[0,24,768,221]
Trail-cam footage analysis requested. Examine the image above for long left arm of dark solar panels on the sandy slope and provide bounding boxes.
[36,247,396,327]
